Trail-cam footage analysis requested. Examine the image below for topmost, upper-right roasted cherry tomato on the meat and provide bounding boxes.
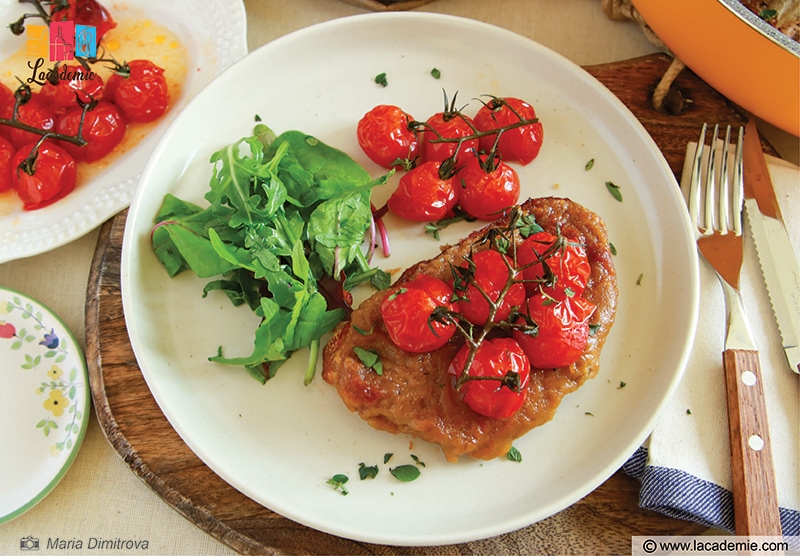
[517,232,592,301]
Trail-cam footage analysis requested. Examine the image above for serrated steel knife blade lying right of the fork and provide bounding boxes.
[743,120,800,374]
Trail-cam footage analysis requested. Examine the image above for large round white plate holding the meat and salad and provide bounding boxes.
[122,13,698,545]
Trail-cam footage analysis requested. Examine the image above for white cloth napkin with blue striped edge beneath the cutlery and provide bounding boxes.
[623,144,800,536]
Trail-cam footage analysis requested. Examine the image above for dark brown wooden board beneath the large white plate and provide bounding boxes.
[86,54,760,556]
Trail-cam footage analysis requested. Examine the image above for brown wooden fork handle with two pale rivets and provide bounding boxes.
[722,349,781,536]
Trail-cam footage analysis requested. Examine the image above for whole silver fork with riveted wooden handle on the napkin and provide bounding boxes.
[687,124,781,536]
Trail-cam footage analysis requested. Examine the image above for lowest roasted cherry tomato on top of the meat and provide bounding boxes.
[448,338,531,419]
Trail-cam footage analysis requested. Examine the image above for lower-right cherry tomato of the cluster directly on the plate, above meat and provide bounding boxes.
[456,155,520,221]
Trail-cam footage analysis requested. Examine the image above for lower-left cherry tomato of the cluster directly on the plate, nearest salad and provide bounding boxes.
[387,160,458,222]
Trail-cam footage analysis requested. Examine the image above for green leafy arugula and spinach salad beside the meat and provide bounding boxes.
[151,124,391,384]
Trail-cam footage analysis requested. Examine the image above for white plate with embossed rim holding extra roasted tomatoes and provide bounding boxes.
[0,0,247,263]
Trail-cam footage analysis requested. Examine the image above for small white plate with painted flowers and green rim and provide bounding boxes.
[0,288,90,523]
